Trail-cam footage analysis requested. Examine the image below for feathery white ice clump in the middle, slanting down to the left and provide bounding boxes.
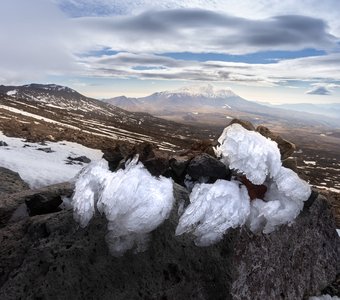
[176,180,250,246]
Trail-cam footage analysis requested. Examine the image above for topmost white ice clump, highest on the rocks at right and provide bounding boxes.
[215,124,281,184]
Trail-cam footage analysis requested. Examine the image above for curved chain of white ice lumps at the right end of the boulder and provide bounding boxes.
[210,123,311,233]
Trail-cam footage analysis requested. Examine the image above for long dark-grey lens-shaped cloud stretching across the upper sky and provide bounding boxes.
[73,9,337,54]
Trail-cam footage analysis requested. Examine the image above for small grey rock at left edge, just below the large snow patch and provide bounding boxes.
[0,167,29,195]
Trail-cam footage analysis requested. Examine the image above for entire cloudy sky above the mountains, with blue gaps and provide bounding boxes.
[0,0,340,103]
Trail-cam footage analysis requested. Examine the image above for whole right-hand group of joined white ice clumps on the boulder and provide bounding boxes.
[176,124,311,246]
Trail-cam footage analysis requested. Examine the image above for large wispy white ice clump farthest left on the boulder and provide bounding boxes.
[72,157,174,256]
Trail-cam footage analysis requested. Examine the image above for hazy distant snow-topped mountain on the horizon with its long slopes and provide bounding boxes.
[103,85,340,127]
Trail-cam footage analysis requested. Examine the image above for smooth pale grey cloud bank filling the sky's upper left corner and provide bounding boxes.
[0,0,79,83]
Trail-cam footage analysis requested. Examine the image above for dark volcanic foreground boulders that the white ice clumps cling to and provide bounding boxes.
[0,120,340,299]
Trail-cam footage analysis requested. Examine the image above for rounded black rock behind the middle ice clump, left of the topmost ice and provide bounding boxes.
[187,153,231,182]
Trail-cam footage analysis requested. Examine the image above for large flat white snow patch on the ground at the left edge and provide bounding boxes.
[0,132,103,188]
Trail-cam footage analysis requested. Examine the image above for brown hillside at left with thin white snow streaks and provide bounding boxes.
[0,84,215,150]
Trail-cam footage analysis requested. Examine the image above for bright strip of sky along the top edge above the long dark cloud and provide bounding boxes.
[51,0,340,36]
